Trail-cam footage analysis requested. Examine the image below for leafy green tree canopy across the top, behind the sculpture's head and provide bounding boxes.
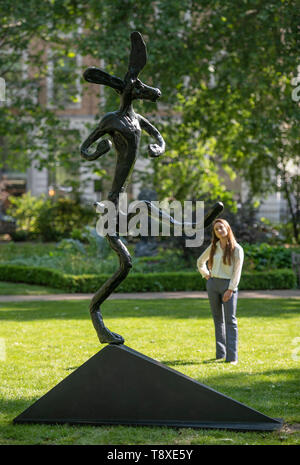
[0,0,300,234]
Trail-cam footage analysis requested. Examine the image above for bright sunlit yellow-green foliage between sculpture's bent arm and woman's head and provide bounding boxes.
[142,121,234,206]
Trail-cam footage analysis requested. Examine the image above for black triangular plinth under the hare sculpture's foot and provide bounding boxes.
[14,345,282,431]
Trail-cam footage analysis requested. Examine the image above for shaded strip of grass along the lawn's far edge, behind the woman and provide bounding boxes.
[0,299,300,321]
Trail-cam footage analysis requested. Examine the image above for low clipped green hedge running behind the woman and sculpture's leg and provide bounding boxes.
[0,264,297,293]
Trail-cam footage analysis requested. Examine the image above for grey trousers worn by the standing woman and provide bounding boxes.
[206,278,238,362]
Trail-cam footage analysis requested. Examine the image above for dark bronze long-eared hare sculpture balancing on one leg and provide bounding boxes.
[81,31,223,344]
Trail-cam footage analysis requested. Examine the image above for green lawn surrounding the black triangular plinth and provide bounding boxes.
[0,299,300,445]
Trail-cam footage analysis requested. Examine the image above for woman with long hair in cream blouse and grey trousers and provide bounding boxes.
[197,218,244,364]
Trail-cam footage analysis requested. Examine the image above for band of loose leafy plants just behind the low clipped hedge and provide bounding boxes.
[0,239,300,275]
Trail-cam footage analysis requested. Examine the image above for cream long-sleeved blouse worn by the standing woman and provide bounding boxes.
[197,241,244,291]
